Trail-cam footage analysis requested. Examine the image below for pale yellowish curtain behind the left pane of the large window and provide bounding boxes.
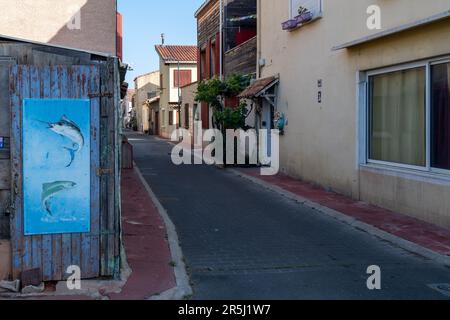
[369,68,426,166]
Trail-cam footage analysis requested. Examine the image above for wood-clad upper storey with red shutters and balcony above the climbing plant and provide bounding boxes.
[195,0,257,129]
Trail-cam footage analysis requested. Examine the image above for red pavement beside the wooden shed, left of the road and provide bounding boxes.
[109,169,176,300]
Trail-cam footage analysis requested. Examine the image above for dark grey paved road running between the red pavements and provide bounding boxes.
[128,134,450,299]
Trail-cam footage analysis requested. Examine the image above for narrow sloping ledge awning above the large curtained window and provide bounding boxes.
[332,10,450,51]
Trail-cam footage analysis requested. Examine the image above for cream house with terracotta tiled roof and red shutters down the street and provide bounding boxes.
[155,45,197,138]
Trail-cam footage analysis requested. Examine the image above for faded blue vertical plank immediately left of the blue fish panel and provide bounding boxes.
[10,66,23,279]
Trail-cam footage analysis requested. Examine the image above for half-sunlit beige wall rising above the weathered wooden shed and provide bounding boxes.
[0,0,116,55]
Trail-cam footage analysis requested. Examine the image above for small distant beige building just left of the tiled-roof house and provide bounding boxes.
[133,71,160,133]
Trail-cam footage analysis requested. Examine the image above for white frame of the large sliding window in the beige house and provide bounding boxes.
[357,56,450,178]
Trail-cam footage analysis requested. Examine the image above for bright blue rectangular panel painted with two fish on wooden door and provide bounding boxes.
[22,99,91,235]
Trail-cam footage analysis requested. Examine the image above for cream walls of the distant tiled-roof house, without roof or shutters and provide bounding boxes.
[159,59,197,138]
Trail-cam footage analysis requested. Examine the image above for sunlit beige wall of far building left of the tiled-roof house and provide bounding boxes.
[133,71,159,132]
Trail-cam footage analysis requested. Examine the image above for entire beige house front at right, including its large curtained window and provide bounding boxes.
[257,0,450,227]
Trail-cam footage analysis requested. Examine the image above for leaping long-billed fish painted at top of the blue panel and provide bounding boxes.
[40,115,84,168]
